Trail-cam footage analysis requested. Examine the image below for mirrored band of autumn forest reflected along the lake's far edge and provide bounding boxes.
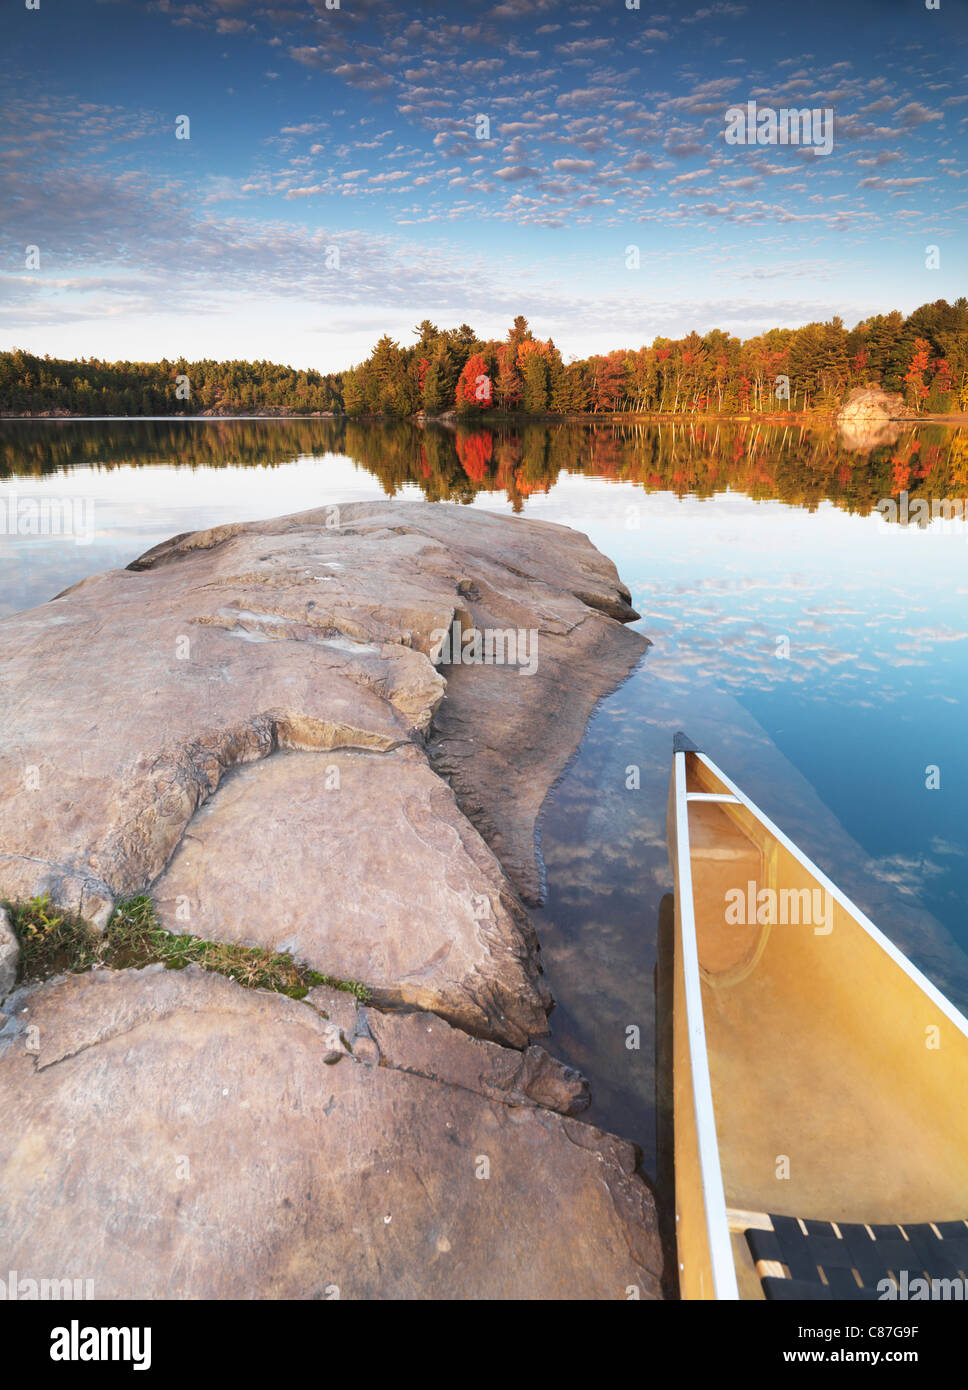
[0,420,968,513]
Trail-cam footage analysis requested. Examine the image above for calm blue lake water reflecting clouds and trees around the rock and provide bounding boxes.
[0,421,968,1168]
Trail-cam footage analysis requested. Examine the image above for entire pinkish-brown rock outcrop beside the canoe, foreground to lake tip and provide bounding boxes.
[0,503,662,1298]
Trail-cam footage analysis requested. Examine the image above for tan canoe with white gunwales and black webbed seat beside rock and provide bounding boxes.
[668,734,968,1300]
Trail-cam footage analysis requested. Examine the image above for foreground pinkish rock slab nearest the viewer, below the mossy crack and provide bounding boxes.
[0,966,661,1300]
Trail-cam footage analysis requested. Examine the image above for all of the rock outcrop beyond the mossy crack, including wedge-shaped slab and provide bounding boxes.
[0,503,645,1044]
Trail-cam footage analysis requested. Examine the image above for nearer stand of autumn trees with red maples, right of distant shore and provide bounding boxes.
[344,297,968,418]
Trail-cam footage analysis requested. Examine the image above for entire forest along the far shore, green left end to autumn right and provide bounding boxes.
[0,296,968,420]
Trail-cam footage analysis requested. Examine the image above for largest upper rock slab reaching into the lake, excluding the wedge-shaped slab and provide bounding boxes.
[0,503,645,924]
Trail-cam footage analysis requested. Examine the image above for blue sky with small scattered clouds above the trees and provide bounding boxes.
[0,0,968,371]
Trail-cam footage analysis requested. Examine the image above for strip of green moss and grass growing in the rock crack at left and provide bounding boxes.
[4,894,370,1004]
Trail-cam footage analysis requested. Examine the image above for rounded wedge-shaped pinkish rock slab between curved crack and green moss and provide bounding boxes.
[152,745,551,1045]
